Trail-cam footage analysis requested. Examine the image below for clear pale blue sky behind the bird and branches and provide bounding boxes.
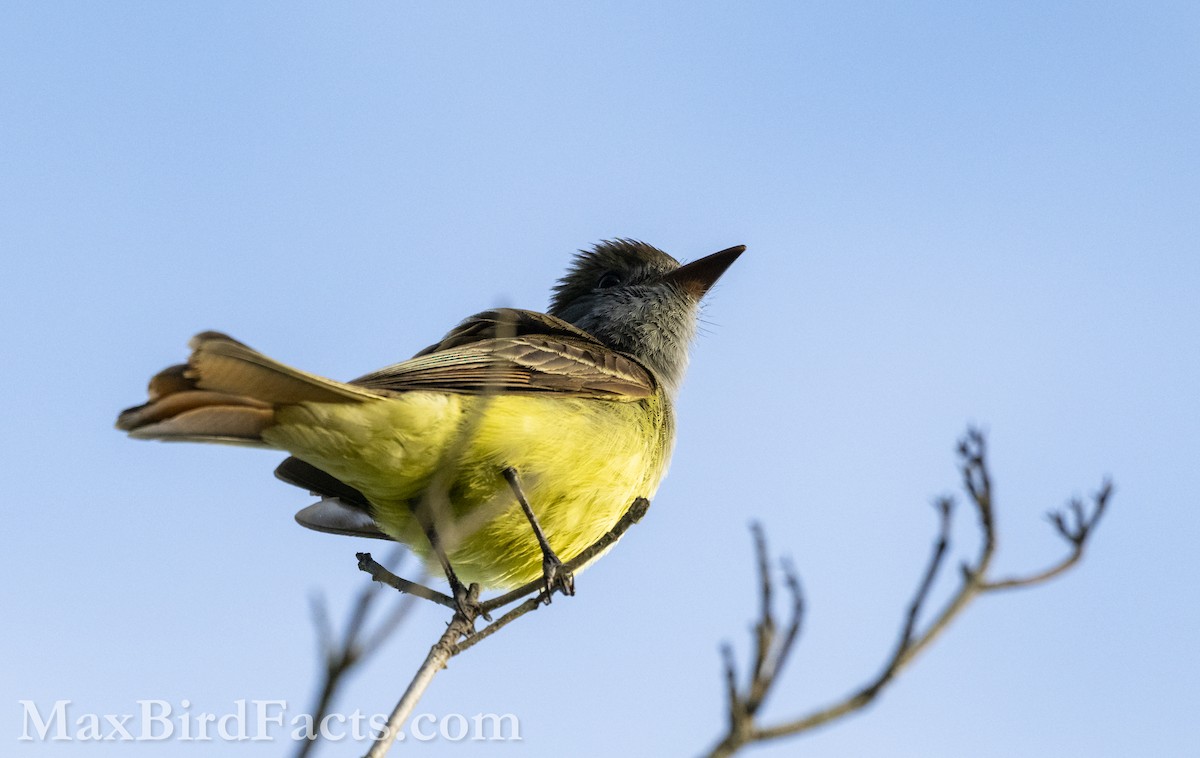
[0,2,1200,758]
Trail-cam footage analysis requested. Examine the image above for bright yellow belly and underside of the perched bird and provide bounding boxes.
[263,392,673,589]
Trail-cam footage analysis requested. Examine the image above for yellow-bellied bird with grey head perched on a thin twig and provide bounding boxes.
[116,240,744,591]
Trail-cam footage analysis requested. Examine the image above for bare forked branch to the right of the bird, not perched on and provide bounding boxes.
[707,428,1112,757]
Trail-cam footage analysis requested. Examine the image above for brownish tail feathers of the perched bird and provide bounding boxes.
[116,332,379,445]
